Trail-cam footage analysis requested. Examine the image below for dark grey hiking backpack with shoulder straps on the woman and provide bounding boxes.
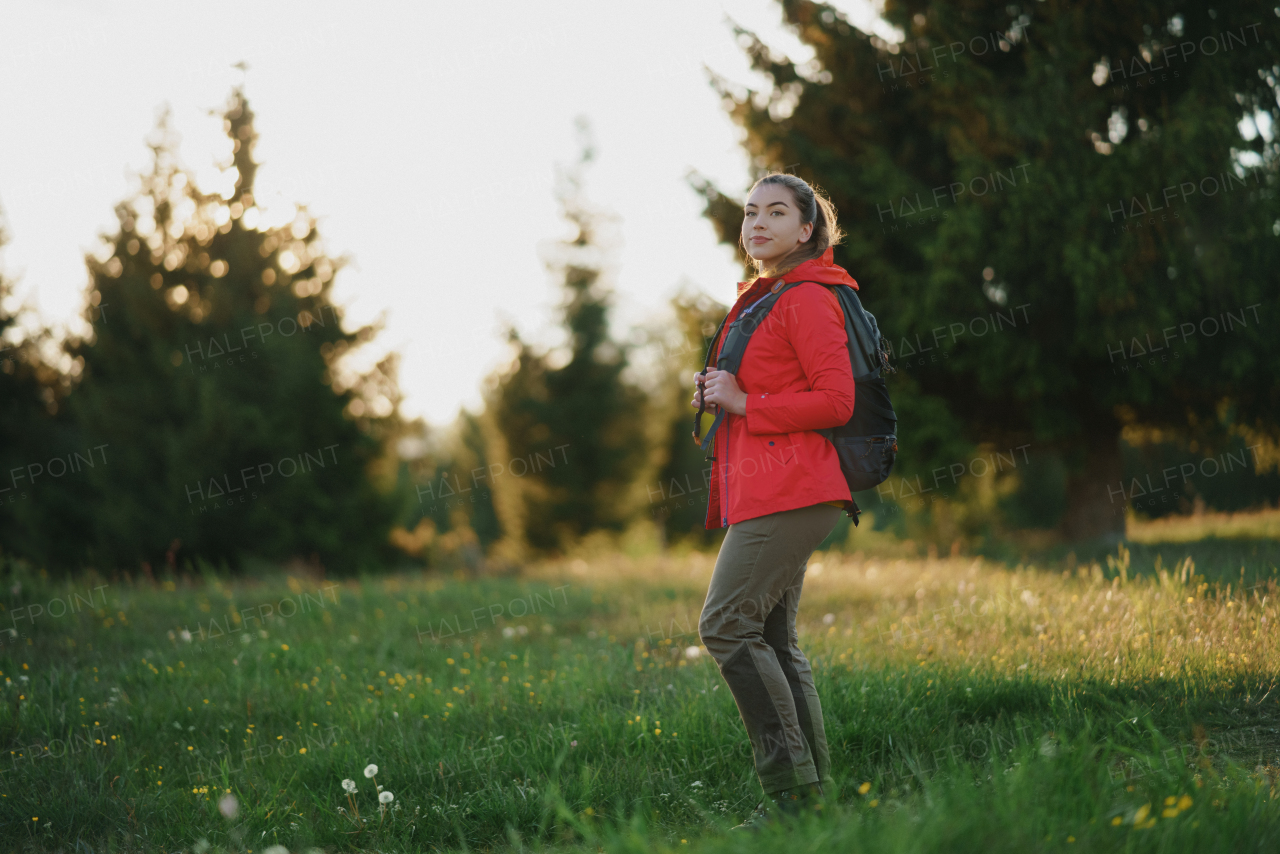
[694,280,897,525]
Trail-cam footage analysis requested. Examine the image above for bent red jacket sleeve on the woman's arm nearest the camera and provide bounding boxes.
[746,284,854,435]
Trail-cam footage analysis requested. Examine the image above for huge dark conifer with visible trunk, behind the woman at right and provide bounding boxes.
[708,0,1280,539]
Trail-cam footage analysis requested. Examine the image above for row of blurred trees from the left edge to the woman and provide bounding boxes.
[0,90,726,574]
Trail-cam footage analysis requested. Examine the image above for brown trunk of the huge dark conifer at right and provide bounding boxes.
[1062,433,1128,544]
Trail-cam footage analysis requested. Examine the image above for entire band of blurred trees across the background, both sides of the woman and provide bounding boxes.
[0,0,1280,574]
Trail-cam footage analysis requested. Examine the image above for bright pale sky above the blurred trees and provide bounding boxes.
[0,0,883,425]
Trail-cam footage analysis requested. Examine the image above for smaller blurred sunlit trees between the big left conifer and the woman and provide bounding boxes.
[396,133,728,570]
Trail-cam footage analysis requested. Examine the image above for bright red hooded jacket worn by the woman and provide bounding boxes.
[707,248,858,530]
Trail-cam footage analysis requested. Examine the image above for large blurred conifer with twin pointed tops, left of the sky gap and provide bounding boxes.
[47,90,399,571]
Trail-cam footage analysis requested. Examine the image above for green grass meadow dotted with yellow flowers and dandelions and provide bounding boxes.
[0,517,1280,854]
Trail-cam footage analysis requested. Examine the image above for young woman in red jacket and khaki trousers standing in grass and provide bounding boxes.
[692,174,858,828]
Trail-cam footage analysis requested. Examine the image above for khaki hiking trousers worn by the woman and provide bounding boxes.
[698,504,844,793]
